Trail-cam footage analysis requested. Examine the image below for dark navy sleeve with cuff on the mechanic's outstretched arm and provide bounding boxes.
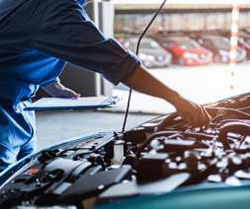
[32,0,140,84]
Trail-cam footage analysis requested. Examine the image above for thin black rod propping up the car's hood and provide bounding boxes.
[122,0,167,133]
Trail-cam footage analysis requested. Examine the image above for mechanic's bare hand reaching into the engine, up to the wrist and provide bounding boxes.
[174,96,211,127]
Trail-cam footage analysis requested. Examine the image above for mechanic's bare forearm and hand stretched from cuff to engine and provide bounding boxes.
[122,66,210,126]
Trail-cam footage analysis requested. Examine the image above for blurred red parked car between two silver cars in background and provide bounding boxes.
[156,36,213,66]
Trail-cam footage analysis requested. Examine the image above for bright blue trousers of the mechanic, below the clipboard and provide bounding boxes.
[0,101,36,171]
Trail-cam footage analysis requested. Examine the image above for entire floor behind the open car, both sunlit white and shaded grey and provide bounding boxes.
[37,61,250,149]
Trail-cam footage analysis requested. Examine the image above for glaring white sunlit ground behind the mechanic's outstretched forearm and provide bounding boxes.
[113,61,250,114]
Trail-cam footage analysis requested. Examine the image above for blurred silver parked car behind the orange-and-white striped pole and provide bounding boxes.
[197,35,246,63]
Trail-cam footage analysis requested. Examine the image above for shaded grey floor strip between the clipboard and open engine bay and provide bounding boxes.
[37,111,157,149]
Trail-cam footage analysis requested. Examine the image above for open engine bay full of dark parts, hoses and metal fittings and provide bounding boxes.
[0,93,250,208]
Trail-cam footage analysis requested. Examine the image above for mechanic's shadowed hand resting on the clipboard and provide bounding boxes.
[41,81,81,98]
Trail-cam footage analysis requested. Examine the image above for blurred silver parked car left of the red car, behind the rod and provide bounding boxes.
[123,37,172,68]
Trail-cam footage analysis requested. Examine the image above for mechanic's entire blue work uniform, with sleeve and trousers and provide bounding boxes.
[0,0,140,170]
